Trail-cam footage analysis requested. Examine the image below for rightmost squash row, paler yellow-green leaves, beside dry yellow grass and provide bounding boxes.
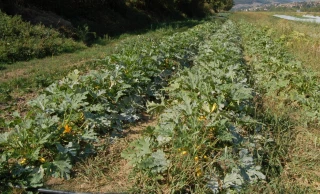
[239,22,320,125]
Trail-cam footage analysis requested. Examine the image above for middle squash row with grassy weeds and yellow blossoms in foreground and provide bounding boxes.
[122,21,272,193]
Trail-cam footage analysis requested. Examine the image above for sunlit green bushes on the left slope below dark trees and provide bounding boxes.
[0,11,85,63]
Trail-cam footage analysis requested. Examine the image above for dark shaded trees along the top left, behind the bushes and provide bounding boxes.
[0,0,233,36]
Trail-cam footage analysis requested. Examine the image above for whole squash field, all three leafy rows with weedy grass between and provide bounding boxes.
[0,10,320,193]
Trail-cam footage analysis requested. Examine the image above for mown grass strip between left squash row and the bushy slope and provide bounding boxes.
[0,20,199,123]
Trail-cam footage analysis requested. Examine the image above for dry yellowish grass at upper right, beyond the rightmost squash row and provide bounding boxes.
[233,12,320,72]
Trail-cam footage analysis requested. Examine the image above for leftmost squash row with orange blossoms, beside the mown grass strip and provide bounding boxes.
[0,18,225,187]
